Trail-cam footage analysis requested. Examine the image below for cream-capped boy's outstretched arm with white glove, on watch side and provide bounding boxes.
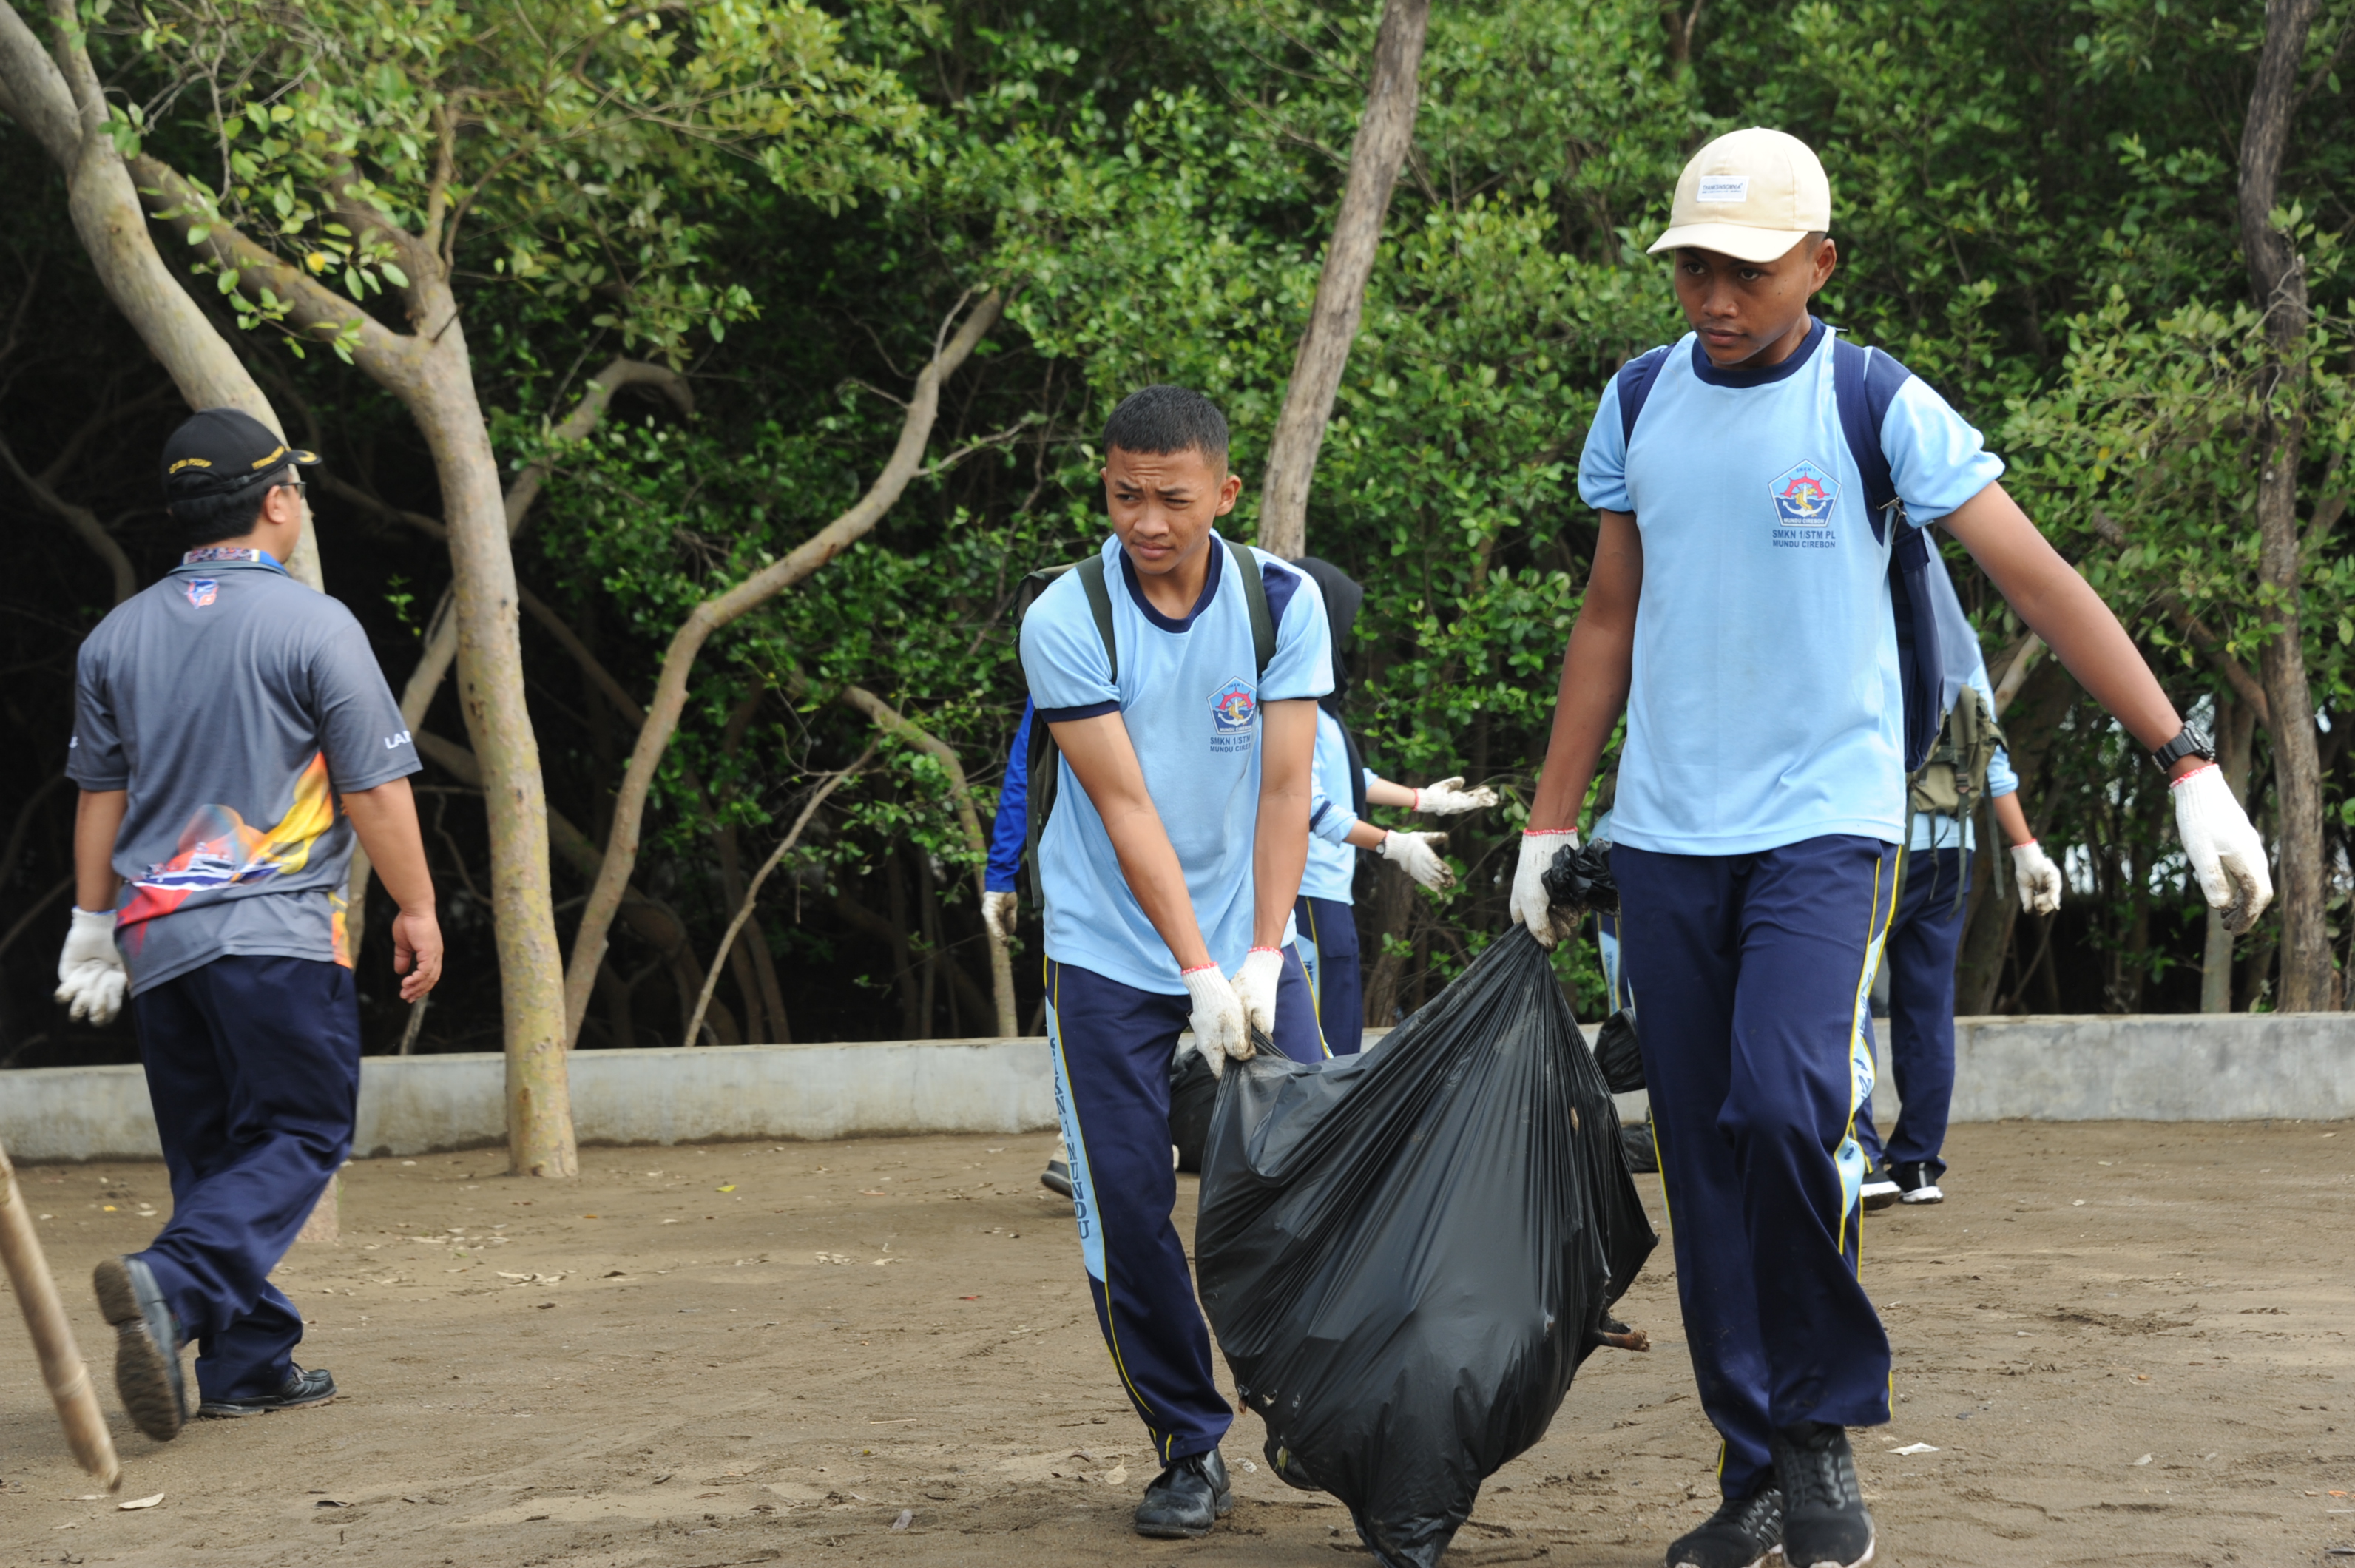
[1941,485,2273,933]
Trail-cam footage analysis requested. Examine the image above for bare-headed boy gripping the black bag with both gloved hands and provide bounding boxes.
[1022,386,1333,1538]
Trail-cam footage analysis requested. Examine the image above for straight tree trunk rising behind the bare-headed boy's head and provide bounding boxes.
[1260,0,1432,561]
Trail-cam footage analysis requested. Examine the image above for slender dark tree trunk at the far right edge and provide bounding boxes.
[2240,0,2339,1013]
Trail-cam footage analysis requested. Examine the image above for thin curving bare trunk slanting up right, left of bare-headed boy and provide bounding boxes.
[563,292,1006,1041]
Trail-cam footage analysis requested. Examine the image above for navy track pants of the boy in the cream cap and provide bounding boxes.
[1611,836,1898,1498]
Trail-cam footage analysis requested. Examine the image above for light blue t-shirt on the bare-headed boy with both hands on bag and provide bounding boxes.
[1022,535,1333,996]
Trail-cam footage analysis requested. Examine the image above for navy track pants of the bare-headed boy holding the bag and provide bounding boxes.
[1046,951,1326,1464]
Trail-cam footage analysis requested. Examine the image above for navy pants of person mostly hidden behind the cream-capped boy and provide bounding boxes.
[1856,850,1971,1180]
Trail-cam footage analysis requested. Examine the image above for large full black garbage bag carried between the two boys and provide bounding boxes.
[1194,927,1655,1568]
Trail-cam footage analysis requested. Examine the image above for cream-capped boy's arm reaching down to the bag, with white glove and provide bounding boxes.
[1510,511,1643,947]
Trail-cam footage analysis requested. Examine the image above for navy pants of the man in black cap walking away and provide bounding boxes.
[132,956,360,1399]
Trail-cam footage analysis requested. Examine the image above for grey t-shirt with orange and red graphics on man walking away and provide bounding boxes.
[66,551,417,993]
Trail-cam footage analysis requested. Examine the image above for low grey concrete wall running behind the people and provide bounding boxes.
[0,1013,2355,1160]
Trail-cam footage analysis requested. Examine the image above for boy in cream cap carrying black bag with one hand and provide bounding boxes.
[1512,129,2273,1568]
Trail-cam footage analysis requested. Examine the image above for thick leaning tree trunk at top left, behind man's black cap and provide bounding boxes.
[0,0,325,589]
